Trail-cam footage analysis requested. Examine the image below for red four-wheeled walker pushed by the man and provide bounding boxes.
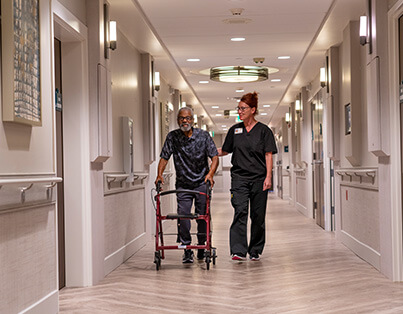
[154,182,217,270]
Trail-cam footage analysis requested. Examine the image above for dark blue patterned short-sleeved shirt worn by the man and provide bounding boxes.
[160,128,218,189]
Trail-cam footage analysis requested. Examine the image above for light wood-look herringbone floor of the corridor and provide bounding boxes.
[60,193,403,313]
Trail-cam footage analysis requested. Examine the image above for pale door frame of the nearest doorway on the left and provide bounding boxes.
[52,1,92,287]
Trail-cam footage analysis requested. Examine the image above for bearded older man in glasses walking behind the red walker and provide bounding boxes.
[155,107,218,263]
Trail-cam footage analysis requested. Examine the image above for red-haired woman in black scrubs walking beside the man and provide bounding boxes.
[219,92,277,261]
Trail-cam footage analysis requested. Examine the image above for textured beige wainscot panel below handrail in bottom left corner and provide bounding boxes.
[0,204,58,313]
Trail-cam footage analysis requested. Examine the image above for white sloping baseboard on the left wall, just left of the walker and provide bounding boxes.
[104,232,147,276]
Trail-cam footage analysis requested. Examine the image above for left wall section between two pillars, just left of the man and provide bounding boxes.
[104,28,150,275]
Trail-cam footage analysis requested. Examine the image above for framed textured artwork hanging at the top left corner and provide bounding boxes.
[1,0,42,126]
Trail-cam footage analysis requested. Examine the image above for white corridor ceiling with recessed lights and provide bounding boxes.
[109,0,365,133]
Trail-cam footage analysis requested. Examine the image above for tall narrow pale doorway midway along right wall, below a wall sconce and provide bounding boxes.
[311,92,325,229]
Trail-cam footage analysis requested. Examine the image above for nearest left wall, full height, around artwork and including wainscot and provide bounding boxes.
[0,0,58,313]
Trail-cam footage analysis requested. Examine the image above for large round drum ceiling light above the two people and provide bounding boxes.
[210,66,269,83]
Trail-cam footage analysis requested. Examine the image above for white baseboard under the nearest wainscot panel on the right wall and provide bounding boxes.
[340,230,381,270]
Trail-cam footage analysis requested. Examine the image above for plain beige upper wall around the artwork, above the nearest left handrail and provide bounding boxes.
[0,0,55,176]
